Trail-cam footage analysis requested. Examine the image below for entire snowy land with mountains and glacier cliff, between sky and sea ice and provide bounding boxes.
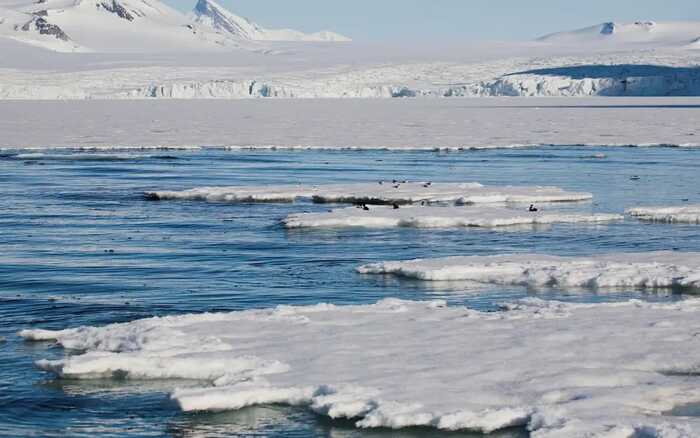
[0,11,700,100]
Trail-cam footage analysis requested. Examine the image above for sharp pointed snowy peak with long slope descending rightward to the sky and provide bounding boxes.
[191,0,350,42]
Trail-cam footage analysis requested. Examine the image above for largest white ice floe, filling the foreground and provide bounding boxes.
[20,296,700,438]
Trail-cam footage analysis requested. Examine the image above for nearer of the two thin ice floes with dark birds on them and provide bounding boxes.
[283,206,624,228]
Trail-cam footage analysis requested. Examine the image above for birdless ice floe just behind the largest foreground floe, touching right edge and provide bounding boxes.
[358,252,700,289]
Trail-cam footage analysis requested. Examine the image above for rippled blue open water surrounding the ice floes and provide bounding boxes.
[0,148,700,437]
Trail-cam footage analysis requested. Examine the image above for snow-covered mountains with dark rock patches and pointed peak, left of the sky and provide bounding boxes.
[0,0,347,52]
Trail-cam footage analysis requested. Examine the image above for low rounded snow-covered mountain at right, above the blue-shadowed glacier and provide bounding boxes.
[538,21,700,47]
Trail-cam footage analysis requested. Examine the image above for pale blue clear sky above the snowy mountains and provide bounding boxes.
[171,0,700,42]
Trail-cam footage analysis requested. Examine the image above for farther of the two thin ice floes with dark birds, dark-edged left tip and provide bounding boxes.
[146,181,593,205]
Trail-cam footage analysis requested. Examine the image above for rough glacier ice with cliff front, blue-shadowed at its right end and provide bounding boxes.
[0,48,700,100]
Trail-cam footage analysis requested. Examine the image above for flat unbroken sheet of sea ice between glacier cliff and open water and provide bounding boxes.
[0,98,700,151]
